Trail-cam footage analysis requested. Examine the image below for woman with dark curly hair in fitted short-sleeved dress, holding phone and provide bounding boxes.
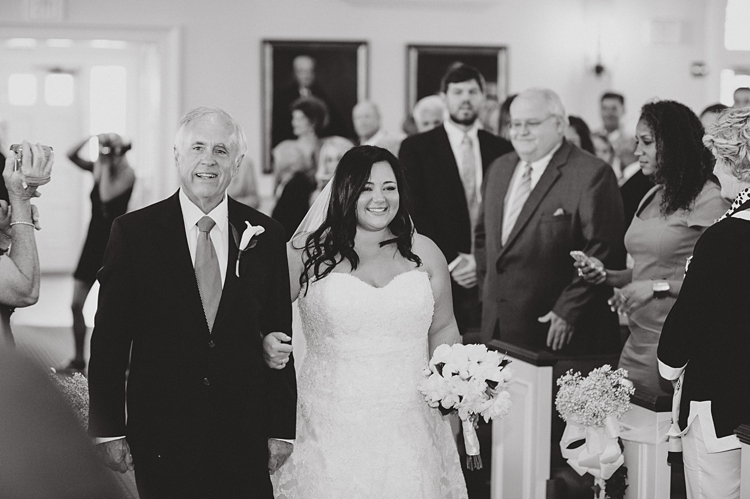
[576,101,729,395]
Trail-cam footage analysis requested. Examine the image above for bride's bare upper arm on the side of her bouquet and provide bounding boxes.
[413,234,461,357]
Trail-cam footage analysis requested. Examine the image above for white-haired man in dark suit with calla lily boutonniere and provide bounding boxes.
[89,108,296,499]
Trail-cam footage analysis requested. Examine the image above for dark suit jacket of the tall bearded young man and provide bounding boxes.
[399,126,513,334]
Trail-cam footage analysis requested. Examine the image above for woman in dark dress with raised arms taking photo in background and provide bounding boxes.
[66,133,135,371]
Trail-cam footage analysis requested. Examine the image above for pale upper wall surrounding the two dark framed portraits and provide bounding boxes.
[0,0,725,197]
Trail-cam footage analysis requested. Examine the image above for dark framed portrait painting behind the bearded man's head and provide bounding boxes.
[406,45,508,116]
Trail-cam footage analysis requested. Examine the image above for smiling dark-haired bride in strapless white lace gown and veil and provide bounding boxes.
[269,146,467,499]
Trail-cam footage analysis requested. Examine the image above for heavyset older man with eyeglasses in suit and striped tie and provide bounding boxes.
[475,89,625,355]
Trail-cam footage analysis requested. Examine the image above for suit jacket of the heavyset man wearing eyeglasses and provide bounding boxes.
[475,141,625,354]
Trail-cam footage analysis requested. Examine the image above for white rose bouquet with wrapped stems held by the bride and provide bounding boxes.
[419,344,511,469]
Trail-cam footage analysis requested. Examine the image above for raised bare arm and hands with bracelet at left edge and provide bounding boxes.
[0,142,54,348]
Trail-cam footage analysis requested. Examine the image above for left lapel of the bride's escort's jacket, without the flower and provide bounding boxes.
[154,194,208,328]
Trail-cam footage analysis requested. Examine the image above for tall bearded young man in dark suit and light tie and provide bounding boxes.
[399,63,513,334]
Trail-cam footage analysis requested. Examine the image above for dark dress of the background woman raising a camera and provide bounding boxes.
[73,183,133,284]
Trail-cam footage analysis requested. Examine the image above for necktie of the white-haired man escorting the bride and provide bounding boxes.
[195,216,221,330]
